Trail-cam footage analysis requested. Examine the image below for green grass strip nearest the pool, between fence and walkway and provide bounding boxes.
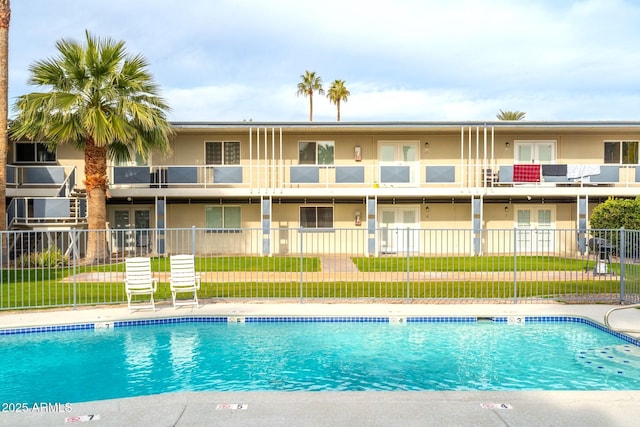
[0,280,620,309]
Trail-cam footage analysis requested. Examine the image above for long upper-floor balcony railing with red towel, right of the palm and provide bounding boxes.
[110,161,640,189]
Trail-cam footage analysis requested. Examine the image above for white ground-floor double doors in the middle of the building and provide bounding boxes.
[378,205,420,254]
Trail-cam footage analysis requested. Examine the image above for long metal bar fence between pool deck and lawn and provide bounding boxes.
[0,227,640,310]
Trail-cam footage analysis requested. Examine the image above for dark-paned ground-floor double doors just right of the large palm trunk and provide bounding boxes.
[111,207,152,254]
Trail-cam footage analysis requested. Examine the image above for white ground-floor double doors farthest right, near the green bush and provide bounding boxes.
[515,206,555,253]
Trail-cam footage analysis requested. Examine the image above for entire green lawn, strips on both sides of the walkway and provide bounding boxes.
[0,256,640,309]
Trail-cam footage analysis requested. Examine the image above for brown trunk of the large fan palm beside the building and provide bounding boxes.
[84,140,109,264]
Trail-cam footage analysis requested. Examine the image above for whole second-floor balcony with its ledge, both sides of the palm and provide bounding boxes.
[7,160,640,198]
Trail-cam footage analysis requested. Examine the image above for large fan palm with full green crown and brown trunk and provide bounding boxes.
[10,31,173,263]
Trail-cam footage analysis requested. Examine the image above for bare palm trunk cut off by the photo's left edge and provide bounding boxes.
[0,0,11,234]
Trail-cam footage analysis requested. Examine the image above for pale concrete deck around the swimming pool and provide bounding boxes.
[0,301,640,427]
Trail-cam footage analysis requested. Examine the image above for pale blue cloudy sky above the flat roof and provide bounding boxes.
[9,0,640,122]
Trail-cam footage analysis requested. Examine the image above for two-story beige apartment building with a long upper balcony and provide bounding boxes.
[7,121,640,255]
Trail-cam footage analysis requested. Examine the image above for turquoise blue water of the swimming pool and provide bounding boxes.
[0,318,640,403]
